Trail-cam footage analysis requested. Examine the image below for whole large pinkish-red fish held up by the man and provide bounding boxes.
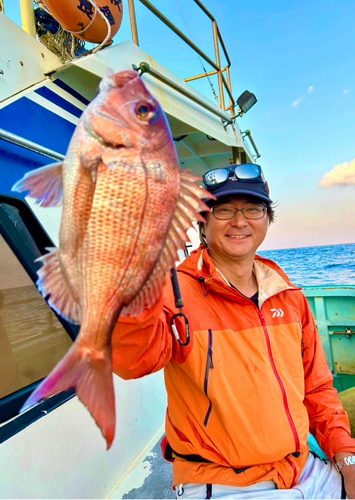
[13,70,214,449]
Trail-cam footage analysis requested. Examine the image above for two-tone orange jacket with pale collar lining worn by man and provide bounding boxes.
[113,248,355,488]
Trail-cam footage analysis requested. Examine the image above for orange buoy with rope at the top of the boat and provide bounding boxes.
[42,0,123,43]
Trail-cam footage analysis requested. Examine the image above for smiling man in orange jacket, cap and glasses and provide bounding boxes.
[113,164,355,498]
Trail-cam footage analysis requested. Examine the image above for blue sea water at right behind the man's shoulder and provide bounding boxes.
[258,243,355,286]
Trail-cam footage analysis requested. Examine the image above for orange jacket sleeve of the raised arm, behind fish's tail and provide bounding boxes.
[112,277,192,380]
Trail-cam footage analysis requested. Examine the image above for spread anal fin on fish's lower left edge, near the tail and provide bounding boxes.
[36,248,81,324]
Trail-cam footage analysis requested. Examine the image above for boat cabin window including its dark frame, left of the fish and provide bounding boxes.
[0,194,79,443]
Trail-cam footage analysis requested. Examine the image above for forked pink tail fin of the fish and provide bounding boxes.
[20,342,116,449]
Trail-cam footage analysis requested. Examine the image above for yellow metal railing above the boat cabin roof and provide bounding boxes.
[128,0,236,118]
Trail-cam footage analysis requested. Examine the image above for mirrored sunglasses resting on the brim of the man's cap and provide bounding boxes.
[202,163,265,187]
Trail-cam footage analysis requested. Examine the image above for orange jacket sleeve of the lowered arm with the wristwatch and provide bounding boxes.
[302,296,355,459]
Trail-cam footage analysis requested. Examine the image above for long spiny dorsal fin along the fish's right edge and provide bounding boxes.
[121,170,214,316]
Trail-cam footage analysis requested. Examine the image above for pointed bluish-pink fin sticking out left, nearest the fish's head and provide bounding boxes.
[12,162,63,207]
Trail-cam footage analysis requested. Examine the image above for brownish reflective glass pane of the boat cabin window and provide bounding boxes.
[0,235,73,400]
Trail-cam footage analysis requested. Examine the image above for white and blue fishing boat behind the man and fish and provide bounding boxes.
[0,0,355,498]
